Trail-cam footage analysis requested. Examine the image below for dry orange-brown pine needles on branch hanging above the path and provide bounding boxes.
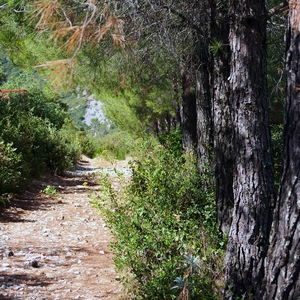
[31,0,126,87]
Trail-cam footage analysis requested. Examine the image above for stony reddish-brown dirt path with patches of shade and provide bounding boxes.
[0,157,125,300]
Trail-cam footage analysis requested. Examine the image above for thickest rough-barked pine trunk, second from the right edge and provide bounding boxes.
[224,0,274,299]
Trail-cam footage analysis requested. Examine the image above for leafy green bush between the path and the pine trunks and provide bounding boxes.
[94,139,224,300]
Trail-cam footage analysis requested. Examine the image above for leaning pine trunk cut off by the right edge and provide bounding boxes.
[263,0,300,300]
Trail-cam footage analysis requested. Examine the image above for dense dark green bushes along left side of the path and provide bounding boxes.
[0,92,81,202]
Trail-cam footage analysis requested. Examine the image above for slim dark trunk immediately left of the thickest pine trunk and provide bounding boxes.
[210,1,234,234]
